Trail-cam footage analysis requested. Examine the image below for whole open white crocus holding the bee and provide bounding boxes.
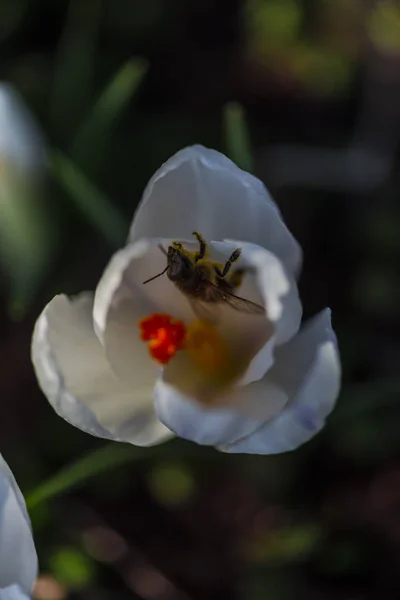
[32,146,340,454]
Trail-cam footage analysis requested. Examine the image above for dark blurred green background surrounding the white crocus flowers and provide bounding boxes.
[0,0,400,600]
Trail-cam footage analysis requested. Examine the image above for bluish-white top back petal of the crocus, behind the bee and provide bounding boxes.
[129,146,301,273]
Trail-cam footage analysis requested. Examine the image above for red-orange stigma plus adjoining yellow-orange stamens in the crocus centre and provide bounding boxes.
[139,313,230,376]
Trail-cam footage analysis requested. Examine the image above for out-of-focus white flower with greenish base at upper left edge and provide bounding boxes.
[0,82,52,310]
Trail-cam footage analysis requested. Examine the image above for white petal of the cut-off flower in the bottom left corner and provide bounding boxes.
[0,455,38,600]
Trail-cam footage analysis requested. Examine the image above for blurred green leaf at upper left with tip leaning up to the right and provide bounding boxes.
[72,58,147,173]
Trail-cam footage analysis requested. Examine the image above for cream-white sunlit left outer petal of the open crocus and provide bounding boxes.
[32,294,170,446]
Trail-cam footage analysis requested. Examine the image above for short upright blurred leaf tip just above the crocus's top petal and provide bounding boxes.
[224,102,253,172]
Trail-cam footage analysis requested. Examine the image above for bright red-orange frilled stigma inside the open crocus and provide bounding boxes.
[139,313,186,365]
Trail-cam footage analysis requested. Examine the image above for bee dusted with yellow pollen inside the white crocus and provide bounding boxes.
[143,231,265,322]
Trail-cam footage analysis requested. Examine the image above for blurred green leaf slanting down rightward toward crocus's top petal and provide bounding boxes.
[51,150,129,247]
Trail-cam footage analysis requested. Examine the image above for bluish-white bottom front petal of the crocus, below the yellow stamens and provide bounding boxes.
[154,380,287,446]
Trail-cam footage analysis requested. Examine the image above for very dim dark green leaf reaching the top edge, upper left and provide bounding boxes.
[50,0,103,140]
